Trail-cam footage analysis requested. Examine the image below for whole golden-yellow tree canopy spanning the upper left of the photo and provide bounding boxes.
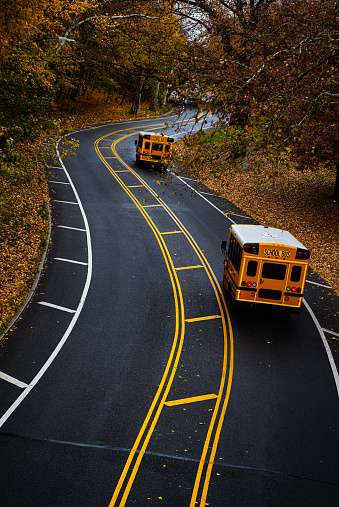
[0,0,184,145]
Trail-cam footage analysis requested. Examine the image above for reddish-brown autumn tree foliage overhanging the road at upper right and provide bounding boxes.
[168,0,339,196]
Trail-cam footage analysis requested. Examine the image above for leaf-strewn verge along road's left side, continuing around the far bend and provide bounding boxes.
[0,92,169,336]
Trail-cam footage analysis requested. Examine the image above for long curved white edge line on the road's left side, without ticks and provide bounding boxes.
[0,141,92,427]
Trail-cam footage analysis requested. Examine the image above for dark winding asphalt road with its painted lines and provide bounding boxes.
[0,110,339,507]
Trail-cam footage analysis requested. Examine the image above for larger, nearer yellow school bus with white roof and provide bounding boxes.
[221,224,310,313]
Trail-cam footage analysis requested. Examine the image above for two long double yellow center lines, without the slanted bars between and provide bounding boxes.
[95,124,234,507]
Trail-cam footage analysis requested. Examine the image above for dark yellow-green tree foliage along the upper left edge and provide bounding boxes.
[0,0,61,143]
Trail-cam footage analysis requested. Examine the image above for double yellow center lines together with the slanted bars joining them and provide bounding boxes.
[95,126,234,507]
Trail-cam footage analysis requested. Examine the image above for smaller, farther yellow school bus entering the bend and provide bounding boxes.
[135,132,174,166]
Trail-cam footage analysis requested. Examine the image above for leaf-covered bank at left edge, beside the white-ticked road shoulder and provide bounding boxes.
[0,155,48,332]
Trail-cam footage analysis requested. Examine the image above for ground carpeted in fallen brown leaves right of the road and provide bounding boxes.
[176,143,339,295]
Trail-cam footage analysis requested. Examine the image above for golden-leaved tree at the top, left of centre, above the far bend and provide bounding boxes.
[32,0,183,111]
